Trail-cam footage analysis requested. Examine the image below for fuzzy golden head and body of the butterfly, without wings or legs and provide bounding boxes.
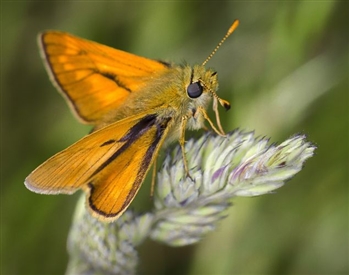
[98,65,218,134]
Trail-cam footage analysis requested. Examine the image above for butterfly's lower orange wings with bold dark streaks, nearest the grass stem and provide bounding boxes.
[25,113,171,221]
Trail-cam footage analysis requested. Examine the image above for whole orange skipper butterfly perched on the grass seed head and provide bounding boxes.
[25,21,238,222]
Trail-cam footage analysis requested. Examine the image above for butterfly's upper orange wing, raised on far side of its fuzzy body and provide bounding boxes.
[39,31,170,124]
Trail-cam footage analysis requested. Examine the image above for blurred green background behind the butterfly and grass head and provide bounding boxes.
[1,1,349,275]
